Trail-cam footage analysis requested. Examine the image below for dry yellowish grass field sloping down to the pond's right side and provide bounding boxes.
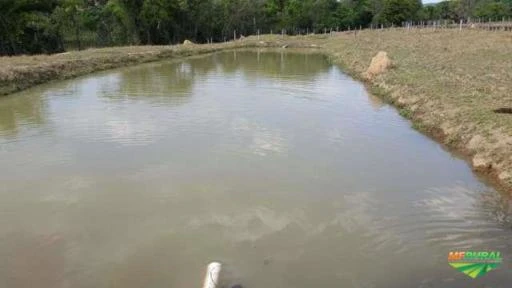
[325,29,512,191]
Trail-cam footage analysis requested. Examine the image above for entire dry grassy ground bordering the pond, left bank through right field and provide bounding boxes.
[0,29,512,191]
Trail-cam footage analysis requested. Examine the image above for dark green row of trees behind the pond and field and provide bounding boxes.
[0,0,512,55]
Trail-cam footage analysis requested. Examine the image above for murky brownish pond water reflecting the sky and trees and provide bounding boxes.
[0,51,512,288]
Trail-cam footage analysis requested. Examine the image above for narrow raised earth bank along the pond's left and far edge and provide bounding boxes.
[0,37,316,96]
